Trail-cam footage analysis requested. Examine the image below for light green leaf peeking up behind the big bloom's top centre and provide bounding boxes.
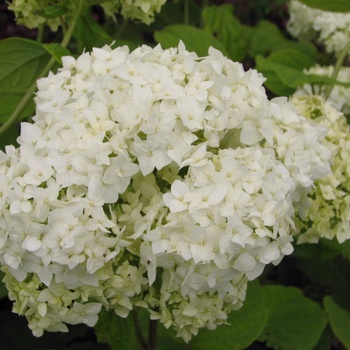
[154,24,227,56]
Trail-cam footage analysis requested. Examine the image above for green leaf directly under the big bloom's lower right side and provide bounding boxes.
[190,281,267,350]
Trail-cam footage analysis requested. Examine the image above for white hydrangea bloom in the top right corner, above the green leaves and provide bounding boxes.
[287,0,350,55]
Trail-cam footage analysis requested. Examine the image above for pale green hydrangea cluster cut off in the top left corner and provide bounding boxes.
[8,0,67,32]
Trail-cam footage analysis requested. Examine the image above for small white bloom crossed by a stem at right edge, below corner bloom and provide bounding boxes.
[295,65,350,115]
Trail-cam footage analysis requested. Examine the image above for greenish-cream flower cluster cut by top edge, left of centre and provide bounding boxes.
[100,0,166,24]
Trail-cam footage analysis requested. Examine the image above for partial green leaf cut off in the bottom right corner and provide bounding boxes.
[323,296,350,349]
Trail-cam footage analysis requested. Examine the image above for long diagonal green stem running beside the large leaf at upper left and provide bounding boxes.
[0,0,85,135]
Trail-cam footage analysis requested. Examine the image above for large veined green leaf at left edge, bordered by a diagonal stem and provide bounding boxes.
[0,38,50,123]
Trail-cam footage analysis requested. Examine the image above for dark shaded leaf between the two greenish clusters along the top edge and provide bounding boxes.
[73,13,113,52]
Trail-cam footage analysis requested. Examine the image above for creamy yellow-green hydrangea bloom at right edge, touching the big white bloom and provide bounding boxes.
[292,96,350,243]
